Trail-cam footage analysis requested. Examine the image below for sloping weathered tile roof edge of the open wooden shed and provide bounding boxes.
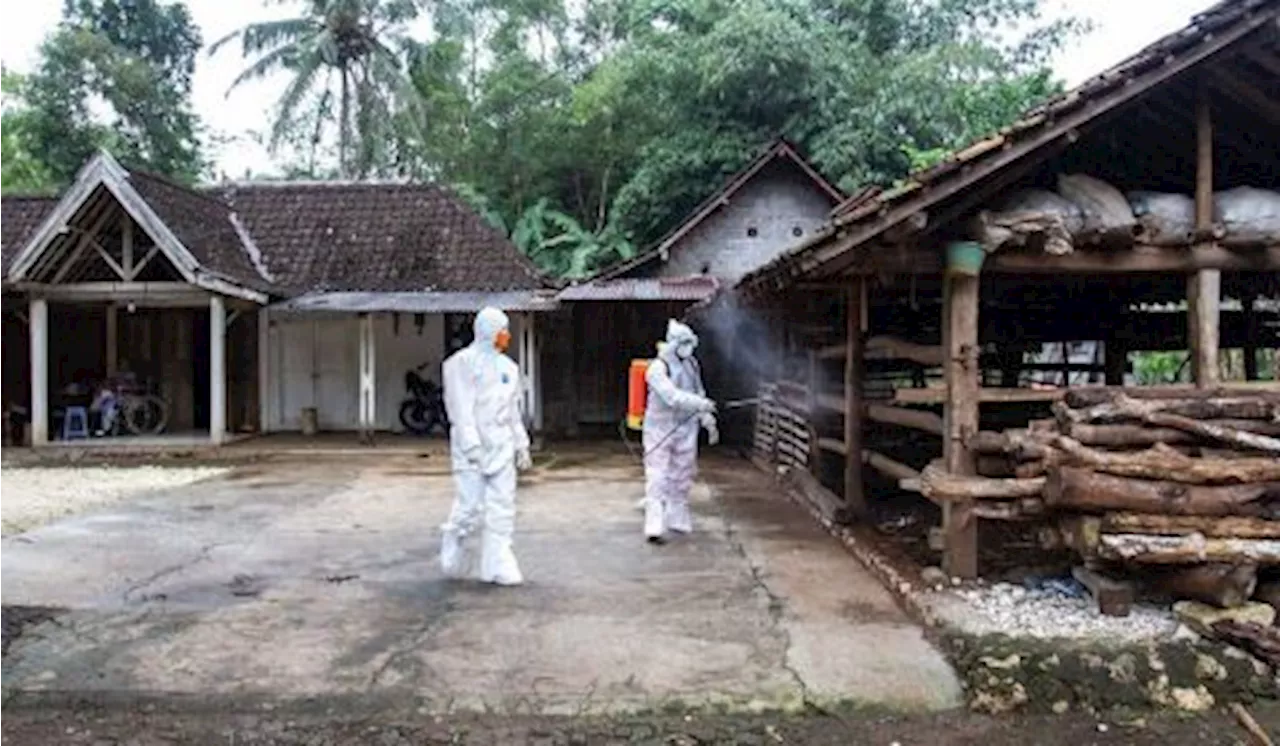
[739,0,1280,296]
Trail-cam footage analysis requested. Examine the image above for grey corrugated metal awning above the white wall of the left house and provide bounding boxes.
[271,290,558,313]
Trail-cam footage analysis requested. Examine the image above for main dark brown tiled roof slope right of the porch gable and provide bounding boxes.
[219,182,548,294]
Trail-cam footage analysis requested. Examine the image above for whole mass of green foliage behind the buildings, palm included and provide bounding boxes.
[0,0,1083,276]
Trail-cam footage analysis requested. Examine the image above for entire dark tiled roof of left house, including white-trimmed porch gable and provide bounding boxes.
[0,154,552,302]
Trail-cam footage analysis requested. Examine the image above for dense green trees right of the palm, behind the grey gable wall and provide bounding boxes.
[264,0,1082,274]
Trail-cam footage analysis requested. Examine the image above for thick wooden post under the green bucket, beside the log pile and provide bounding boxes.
[942,274,980,578]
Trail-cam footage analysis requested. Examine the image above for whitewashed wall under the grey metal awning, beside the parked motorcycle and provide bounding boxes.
[266,313,444,431]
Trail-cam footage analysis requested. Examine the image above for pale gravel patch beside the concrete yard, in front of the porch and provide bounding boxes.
[0,466,230,536]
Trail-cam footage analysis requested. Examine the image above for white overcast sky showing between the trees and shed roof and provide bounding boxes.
[0,0,1217,178]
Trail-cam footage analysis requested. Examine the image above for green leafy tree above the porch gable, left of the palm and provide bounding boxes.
[27,0,205,183]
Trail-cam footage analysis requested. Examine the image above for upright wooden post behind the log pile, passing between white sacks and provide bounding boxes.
[1187,81,1222,388]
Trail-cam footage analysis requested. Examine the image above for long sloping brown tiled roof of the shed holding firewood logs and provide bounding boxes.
[737,0,1280,298]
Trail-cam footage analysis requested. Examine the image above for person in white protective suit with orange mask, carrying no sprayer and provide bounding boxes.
[440,308,531,585]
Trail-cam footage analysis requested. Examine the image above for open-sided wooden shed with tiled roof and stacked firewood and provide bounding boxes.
[737,0,1280,598]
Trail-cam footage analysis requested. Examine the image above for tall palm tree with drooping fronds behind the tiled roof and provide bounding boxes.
[209,0,422,178]
